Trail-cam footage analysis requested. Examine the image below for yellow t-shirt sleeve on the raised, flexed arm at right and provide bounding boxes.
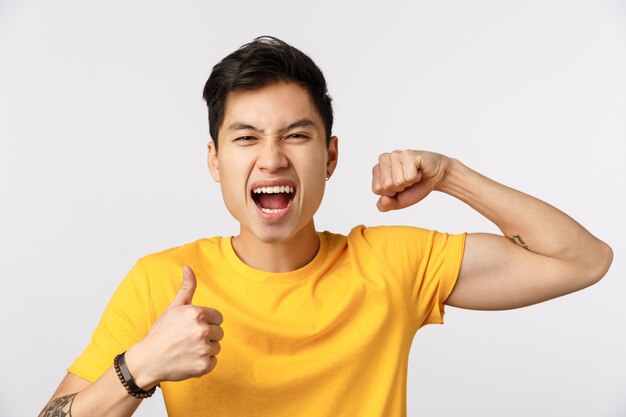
[363,226,467,330]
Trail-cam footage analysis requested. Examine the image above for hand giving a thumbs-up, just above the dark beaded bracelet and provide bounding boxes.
[126,266,224,390]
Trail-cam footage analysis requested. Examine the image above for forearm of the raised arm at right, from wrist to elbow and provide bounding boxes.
[439,159,612,279]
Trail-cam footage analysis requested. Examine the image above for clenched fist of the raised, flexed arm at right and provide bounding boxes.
[372,150,450,211]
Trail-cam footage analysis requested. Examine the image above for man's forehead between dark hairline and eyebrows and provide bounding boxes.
[220,82,323,130]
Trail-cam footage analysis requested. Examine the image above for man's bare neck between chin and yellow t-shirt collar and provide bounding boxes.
[232,220,320,272]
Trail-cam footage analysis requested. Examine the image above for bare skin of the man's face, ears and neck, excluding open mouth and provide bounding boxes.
[208,83,338,272]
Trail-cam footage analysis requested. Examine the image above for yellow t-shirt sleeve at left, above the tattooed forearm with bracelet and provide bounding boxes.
[67,260,153,382]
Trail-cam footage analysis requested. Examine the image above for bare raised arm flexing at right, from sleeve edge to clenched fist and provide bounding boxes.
[372,150,613,310]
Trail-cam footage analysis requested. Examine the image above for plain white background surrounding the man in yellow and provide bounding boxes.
[0,0,626,417]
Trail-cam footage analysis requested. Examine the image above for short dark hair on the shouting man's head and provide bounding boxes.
[202,36,333,148]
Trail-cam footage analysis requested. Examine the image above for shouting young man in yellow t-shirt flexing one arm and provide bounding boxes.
[41,37,612,417]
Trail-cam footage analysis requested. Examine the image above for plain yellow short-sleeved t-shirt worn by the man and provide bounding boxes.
[68,226,466,417]
